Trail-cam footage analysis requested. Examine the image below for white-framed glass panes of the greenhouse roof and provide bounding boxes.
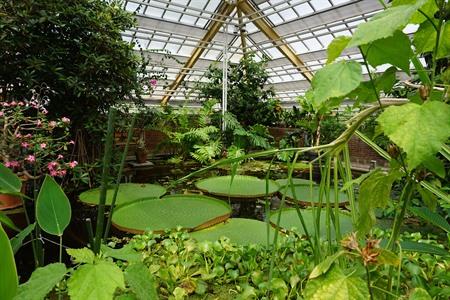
[119,0,416,105]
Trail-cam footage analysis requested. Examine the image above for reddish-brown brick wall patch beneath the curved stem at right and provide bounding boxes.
[348,136,388,167]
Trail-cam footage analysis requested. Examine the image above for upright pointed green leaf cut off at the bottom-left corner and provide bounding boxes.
[0,224,19,300]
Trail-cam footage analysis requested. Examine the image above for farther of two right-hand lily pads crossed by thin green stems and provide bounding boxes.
[280,184,348,205]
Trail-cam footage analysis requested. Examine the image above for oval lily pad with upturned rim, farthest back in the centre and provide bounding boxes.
[195,175,279,198]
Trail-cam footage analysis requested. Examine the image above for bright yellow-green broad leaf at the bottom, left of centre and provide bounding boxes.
[67,260,125,300]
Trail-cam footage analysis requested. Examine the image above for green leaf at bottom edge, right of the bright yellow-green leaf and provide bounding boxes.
[125,263,159,300]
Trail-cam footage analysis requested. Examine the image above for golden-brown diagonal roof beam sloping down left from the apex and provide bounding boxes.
[161,0,235,105]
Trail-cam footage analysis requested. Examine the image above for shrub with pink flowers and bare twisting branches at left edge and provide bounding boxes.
[0,93,78,178]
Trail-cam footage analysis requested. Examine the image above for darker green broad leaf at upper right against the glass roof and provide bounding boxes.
[361,31,413,74]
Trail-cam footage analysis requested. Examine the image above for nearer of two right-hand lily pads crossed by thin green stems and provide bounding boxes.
[270,208,353,238]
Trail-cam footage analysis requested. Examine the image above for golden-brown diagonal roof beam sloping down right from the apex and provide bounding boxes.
[237,0,313,82]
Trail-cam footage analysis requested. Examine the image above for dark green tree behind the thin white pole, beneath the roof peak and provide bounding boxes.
[197,54,281,126]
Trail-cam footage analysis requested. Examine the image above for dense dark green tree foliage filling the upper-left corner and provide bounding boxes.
[0,0,144,128]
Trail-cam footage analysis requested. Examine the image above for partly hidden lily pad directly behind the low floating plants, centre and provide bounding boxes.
[191,218,275,245]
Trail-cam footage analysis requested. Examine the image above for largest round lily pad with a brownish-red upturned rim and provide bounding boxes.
[112,195,231,233]
